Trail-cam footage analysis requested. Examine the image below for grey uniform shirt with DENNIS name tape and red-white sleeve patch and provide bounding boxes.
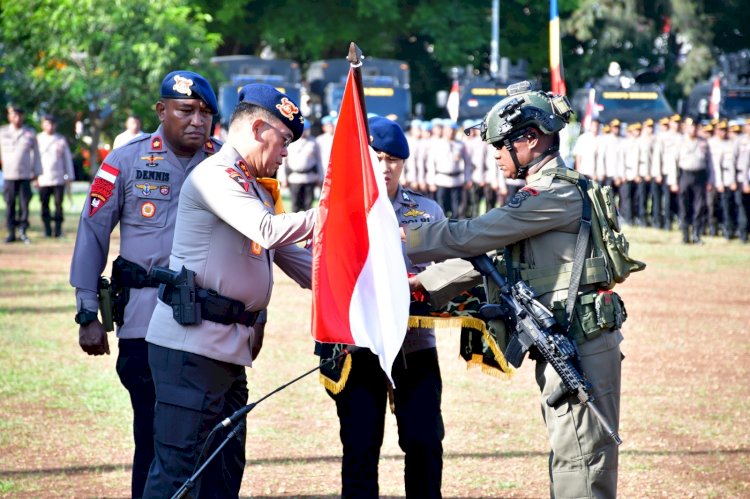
[70,127,221,338]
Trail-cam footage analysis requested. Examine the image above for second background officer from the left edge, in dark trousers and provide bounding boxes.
[36,114,75,237]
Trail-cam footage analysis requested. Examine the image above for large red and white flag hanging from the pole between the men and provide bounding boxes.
[312,64,409,381]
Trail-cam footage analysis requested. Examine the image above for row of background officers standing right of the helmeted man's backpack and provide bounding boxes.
[573,115,750,244]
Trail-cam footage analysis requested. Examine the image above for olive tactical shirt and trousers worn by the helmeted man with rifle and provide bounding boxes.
[406,157,622,499]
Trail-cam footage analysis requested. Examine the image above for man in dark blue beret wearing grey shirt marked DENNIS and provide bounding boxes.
[70,71,221,497]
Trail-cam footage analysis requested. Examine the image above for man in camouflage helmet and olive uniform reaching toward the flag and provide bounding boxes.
[405,87,622,498]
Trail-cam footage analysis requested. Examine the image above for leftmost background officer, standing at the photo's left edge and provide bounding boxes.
[0,105,42,243]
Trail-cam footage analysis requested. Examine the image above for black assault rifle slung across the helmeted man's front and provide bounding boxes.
[466,255,622,445]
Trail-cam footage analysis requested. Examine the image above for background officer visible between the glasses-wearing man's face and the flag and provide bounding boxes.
[278,121,322,211]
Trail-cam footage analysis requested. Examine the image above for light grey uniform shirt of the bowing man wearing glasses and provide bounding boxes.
[146,144,317,366]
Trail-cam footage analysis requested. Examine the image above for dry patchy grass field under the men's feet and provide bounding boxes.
[0,196,750,498]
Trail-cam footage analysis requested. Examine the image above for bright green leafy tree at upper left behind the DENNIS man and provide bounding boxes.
[0,0,220,176]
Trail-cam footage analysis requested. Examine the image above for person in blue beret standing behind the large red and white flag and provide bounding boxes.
[329,116,445,498]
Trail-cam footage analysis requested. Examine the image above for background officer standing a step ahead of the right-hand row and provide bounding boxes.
[671,117,713,244]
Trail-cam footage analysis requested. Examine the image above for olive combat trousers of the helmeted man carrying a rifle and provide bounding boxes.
[536,330,622,499]
